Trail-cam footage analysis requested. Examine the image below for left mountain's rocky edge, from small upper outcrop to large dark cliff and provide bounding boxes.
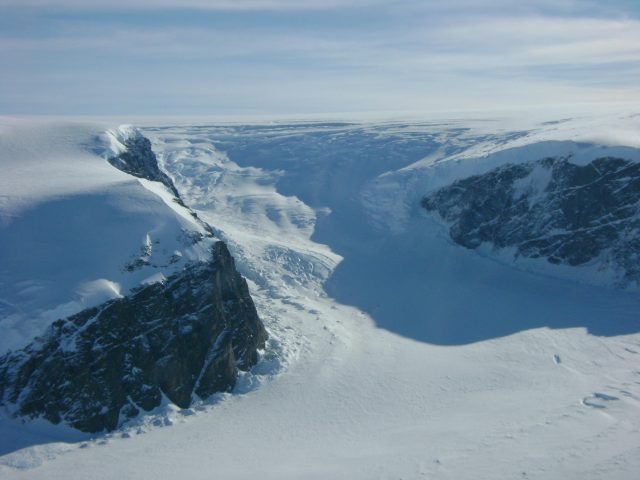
[0,123,267,432]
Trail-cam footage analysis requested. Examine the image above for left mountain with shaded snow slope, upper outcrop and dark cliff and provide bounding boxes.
[0,119,267,432]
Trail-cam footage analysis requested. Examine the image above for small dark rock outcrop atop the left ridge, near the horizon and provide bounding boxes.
[109,129,180,199]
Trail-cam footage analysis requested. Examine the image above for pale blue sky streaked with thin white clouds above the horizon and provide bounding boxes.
[0,0,640,115]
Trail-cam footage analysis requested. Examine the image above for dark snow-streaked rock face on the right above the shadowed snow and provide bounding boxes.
[422,157,640,285]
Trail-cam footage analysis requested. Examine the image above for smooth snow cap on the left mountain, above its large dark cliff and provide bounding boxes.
[0,119,211,353]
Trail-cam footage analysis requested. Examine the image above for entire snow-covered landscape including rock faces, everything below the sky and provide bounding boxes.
[0,115,640,479]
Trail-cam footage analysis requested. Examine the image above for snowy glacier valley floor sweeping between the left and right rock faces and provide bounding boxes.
[0,116,640,480]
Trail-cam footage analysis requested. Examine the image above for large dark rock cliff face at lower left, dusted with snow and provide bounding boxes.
[0,242,267,432]
